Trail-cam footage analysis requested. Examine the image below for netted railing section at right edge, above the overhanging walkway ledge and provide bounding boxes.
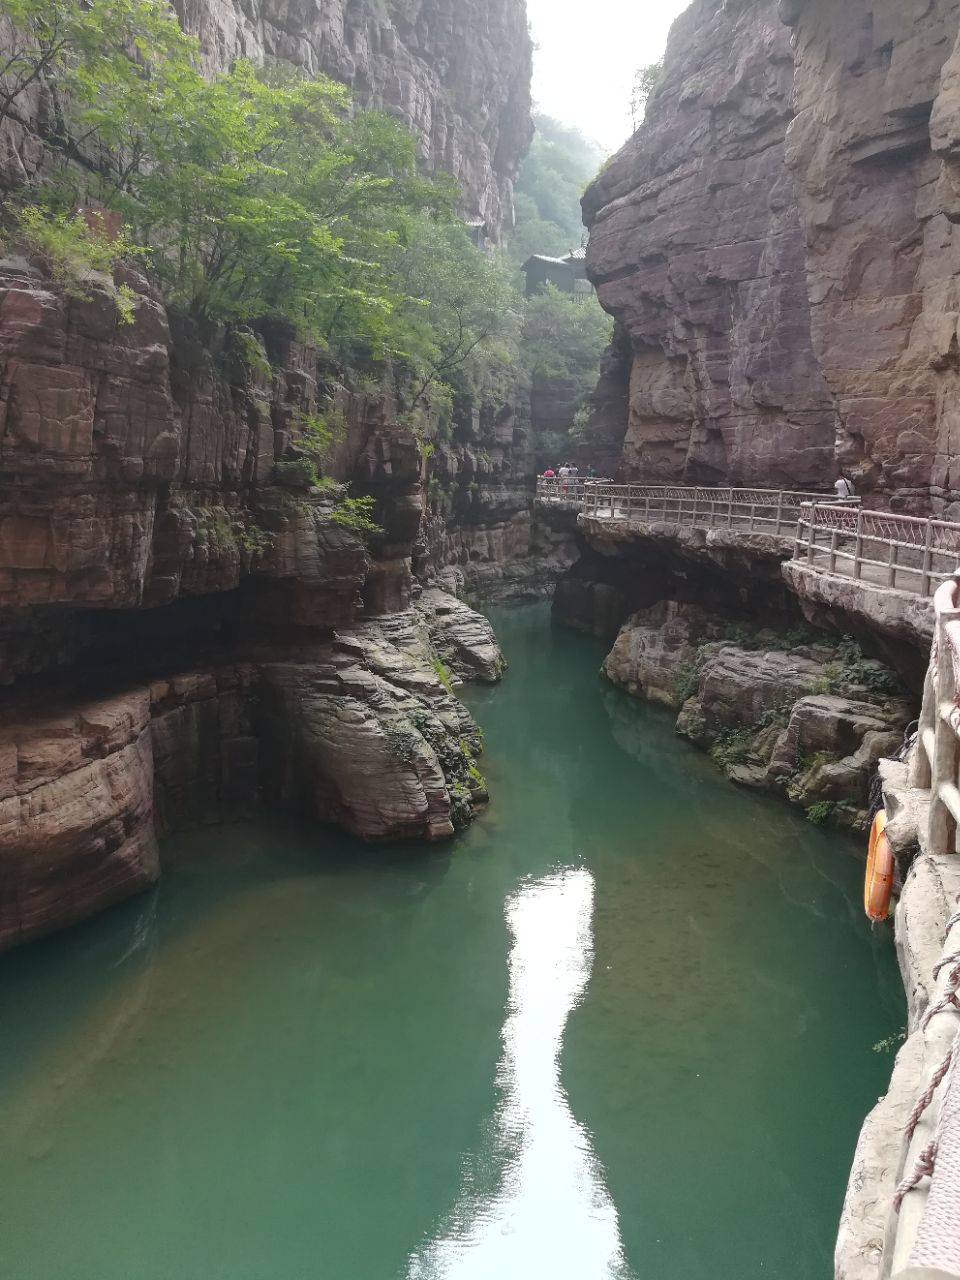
[794,500,960,598]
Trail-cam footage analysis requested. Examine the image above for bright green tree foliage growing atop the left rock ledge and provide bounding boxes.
[0,0,516,392]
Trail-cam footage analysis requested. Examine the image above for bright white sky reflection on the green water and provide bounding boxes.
[407,868,630,1280]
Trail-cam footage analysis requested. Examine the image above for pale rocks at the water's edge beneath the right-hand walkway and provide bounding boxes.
[603,602,911,827]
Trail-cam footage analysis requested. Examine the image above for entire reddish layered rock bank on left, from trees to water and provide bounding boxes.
[0,262,512,945]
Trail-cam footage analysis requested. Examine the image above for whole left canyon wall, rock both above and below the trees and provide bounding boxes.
[0,0,531,948]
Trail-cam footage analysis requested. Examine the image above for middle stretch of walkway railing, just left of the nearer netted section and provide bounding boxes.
[582,484,855,538]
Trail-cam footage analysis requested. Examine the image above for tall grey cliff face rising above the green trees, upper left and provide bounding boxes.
[0,0,532,242]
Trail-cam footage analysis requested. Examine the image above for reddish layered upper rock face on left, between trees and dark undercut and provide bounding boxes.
[0,268,450,682]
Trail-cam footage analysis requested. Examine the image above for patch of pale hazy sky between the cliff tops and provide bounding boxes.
[527,0,690,151]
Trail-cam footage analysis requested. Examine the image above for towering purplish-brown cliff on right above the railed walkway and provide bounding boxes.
[584,0,960,517]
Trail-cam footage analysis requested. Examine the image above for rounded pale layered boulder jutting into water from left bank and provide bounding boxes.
[261,606,491,840]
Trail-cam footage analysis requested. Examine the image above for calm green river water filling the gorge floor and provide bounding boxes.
[0,607,904,1280]
